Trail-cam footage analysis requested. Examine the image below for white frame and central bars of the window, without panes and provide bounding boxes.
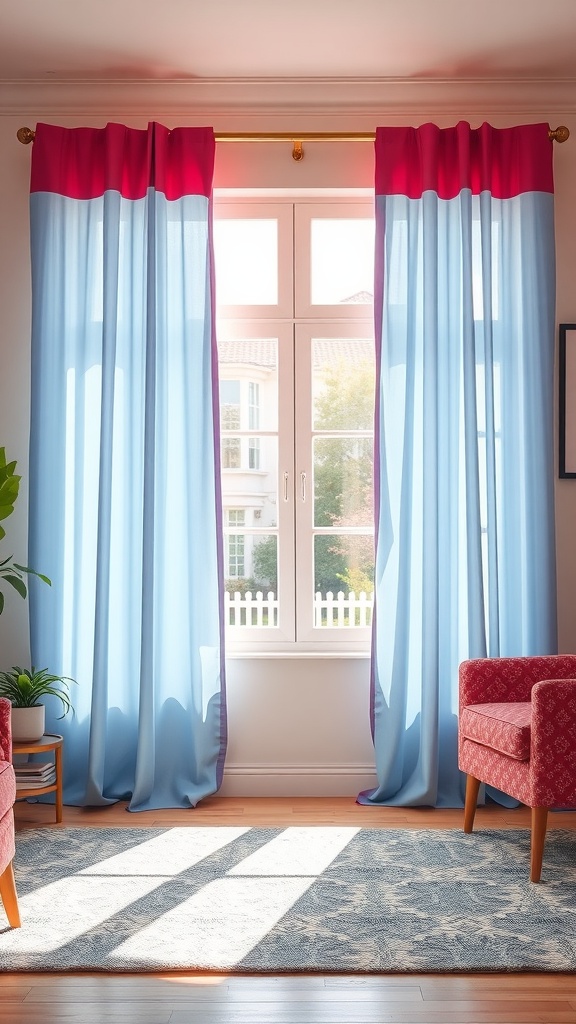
[214,196,374,654]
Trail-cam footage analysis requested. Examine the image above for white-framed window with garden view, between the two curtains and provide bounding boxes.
[214,199,374,649]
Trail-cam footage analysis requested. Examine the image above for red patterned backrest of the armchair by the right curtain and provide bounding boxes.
[458,654,576,710]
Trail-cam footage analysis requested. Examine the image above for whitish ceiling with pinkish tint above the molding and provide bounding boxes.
[0,0,576,82]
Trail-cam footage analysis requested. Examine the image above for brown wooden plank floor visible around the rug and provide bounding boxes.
[0,798,576,1024]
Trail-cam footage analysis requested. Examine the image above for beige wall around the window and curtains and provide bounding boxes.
[0,82,576,795]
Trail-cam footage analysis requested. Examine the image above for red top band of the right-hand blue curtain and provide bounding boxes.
[374,121,553,199]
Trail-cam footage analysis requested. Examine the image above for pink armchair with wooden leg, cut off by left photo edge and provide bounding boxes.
[0,697,20,928]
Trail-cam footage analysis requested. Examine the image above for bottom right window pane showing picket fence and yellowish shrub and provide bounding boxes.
[314,535,374,629]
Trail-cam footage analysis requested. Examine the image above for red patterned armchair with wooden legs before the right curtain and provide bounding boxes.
[458,654,576,882]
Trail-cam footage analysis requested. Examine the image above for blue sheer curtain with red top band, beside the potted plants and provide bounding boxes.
[30,124,227,811]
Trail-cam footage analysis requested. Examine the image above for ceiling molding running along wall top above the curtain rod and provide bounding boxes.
[0,78,576,120]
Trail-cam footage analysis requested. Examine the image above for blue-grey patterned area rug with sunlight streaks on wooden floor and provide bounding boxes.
[0,826,576,973]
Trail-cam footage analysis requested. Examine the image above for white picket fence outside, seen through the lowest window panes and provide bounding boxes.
[224,590,374,629]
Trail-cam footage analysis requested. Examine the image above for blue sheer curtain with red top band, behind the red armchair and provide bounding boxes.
[359,123,557,807]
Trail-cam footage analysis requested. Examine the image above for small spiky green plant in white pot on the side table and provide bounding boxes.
[0,665,76,742]
